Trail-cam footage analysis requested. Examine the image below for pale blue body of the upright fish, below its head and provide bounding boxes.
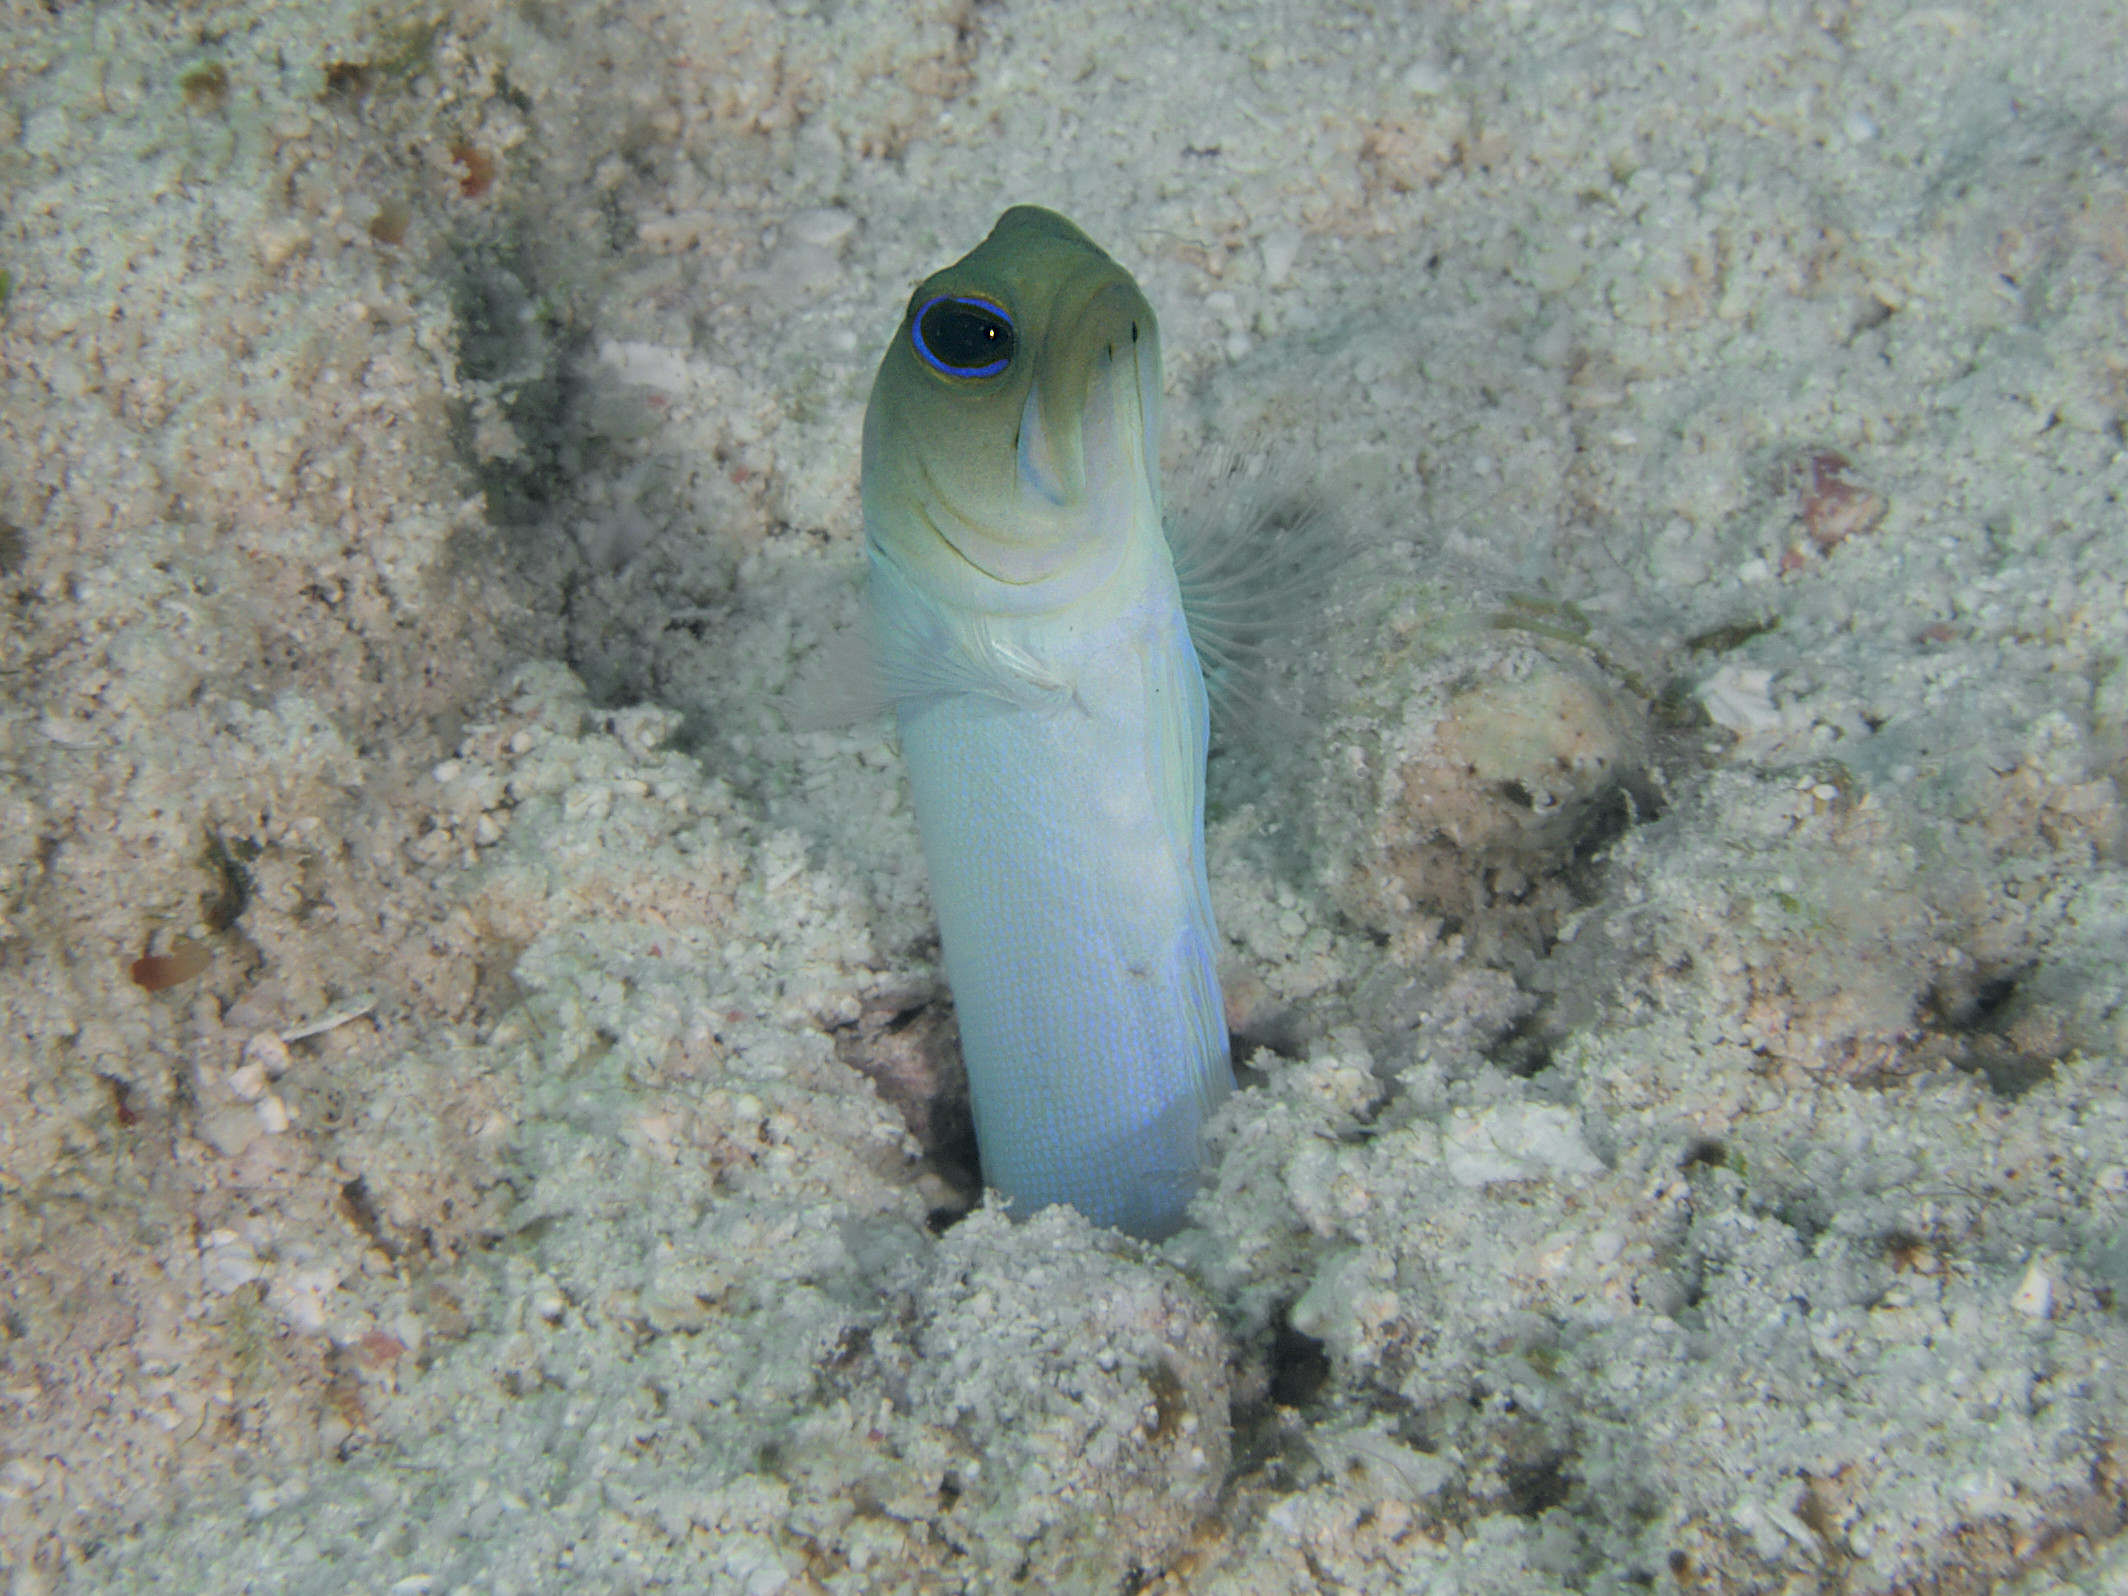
[872,545,1234,1236]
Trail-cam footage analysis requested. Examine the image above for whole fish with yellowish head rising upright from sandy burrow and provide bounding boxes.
[864,206,1234,1238]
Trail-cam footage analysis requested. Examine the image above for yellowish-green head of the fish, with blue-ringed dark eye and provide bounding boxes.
[864,204,1166,615]
